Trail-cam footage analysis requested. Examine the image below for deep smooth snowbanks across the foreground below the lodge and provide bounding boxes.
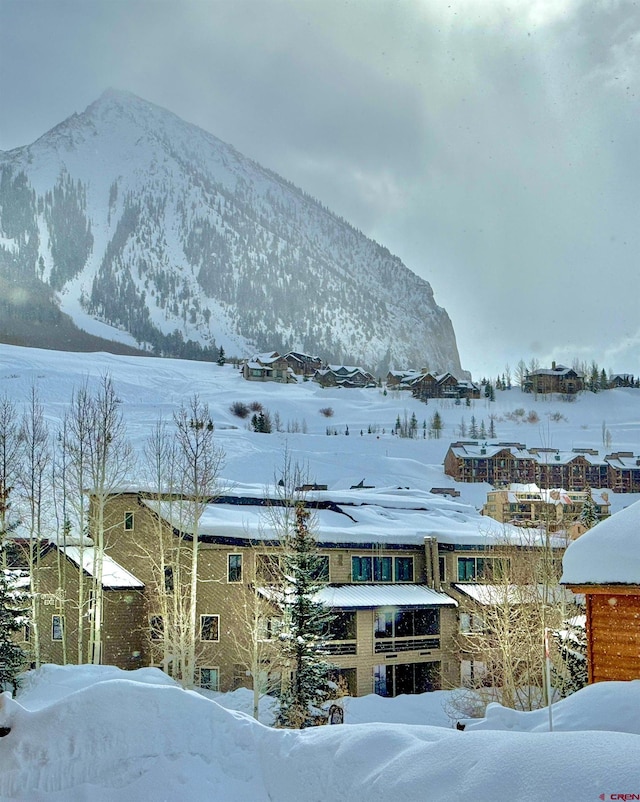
[0,666,640,802]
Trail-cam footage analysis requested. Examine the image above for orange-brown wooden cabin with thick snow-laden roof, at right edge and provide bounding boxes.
[561,502,640,682]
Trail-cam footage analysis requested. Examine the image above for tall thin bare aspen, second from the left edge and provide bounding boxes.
[19,386,51,668]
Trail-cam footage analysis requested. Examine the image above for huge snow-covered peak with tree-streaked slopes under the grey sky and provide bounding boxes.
[0,90,461,376]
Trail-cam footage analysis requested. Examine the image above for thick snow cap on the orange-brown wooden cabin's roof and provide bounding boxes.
[561,501,640,586]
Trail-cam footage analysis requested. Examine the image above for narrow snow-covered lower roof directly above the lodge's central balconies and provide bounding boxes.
[315,584,458,608]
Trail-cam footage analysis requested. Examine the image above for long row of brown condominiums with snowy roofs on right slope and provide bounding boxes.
[444,440,640,493]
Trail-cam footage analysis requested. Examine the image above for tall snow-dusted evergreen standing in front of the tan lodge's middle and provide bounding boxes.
[278,502,334,728]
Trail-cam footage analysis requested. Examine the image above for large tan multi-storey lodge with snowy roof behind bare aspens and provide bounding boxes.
[20,488,568,696]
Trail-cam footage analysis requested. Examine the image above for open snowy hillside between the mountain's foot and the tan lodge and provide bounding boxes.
[0,345,640,516]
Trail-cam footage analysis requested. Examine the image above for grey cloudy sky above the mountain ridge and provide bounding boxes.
[0,0,640,376]
